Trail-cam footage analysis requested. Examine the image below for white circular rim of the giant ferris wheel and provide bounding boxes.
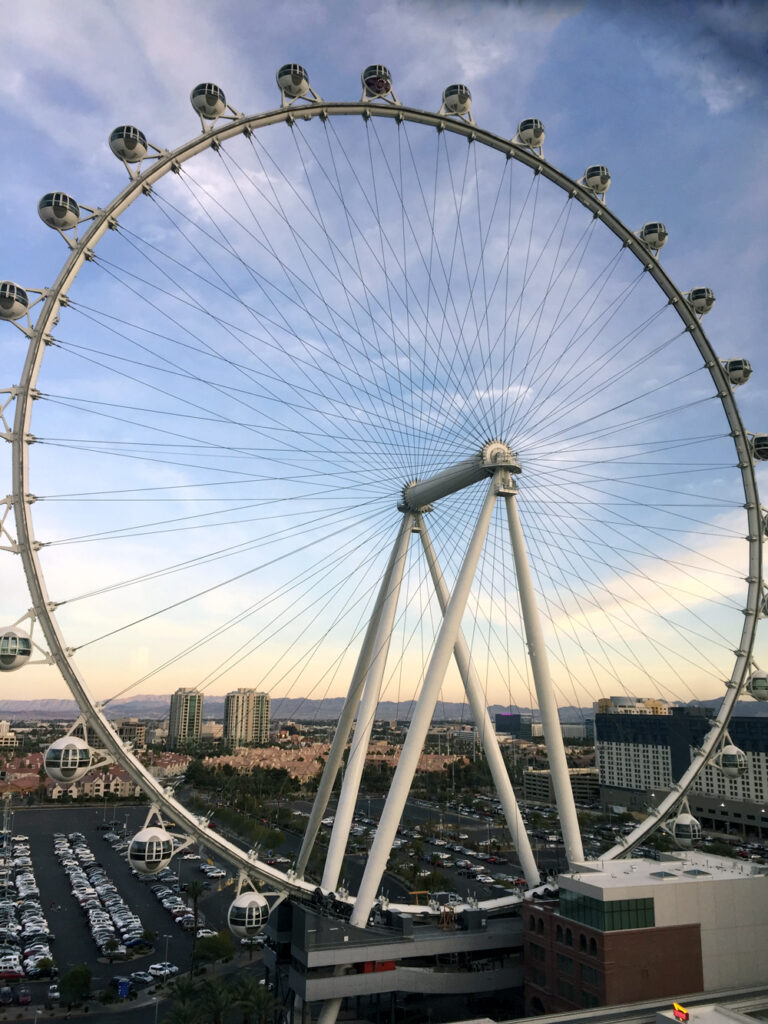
[4,92,762,894]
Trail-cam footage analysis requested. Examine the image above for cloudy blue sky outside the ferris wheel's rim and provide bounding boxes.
[0,0,768,702]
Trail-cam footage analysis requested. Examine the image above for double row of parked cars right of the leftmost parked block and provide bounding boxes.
[53,833,151,959]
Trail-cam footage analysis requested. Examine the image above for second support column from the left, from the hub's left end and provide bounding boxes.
[321,512,415,890]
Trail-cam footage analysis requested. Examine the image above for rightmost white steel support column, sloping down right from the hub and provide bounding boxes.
[502,478,584,868]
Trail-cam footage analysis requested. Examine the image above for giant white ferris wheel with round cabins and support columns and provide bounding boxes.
[0,65,768,950]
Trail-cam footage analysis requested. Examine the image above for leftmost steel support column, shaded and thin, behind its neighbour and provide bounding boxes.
[296,516,413,879]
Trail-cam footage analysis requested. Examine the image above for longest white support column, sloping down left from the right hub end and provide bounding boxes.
[349,473,499,928]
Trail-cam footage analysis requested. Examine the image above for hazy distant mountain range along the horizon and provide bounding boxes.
[0,693,768,725]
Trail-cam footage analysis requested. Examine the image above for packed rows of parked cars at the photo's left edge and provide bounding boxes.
[0,836,54,978]
